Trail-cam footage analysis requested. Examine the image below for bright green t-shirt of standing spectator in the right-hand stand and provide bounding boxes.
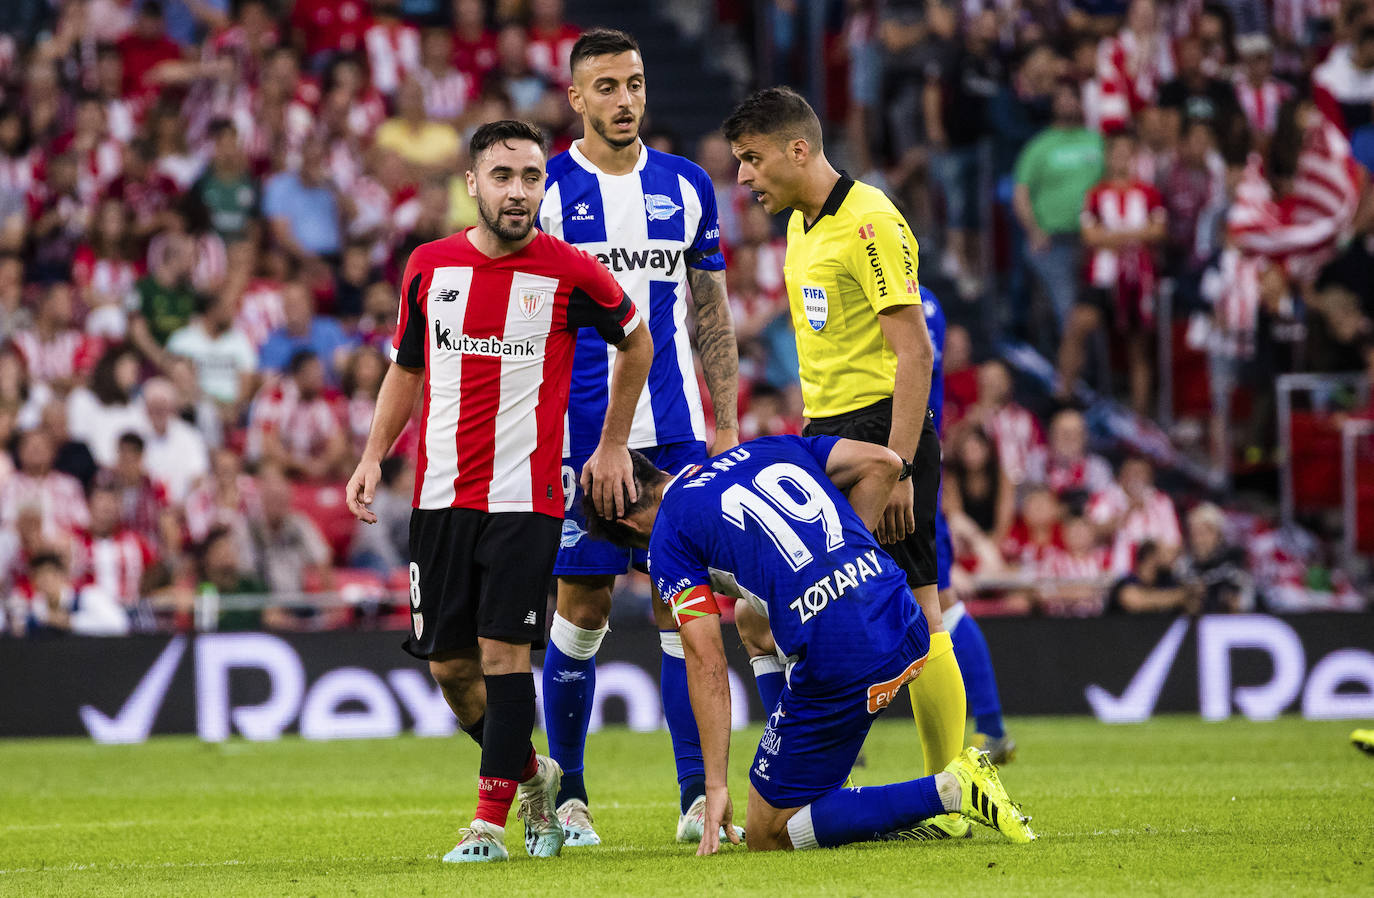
[1015,125,1102,235]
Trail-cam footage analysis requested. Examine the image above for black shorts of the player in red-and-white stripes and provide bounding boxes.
[404,508,562,658]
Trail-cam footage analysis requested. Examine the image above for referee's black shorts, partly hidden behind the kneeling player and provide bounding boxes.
[805,400,940,589]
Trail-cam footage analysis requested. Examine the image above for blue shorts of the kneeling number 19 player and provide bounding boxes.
[749,617,930,807]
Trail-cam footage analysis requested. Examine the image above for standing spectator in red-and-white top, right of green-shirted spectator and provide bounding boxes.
[1059,133,1168,415]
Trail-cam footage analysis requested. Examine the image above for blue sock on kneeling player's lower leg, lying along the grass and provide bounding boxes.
[787,776,945,849]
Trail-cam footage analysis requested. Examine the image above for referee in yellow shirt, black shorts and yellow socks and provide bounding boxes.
[723,88,965,796]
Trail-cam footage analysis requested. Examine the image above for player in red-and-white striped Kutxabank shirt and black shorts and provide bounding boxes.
[346,121,653,862]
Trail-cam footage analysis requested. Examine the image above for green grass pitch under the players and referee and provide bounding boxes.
[0,717,1374,898]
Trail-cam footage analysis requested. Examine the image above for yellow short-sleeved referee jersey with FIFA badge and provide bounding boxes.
[783,176,921,417]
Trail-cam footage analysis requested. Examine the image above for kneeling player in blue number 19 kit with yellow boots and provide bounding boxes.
[587,437,1035,854]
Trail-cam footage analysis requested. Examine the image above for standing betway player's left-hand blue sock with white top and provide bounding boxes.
[544,614,606,805]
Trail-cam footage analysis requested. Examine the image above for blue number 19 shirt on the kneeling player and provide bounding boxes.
[649,437,921,695]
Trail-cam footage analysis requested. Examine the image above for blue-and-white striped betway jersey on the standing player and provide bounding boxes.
[539,144,725,456]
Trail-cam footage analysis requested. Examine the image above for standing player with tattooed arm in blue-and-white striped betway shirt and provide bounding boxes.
[539,29,739,847]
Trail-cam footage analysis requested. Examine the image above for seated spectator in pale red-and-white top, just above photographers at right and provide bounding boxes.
[1088,457,1183,575]
